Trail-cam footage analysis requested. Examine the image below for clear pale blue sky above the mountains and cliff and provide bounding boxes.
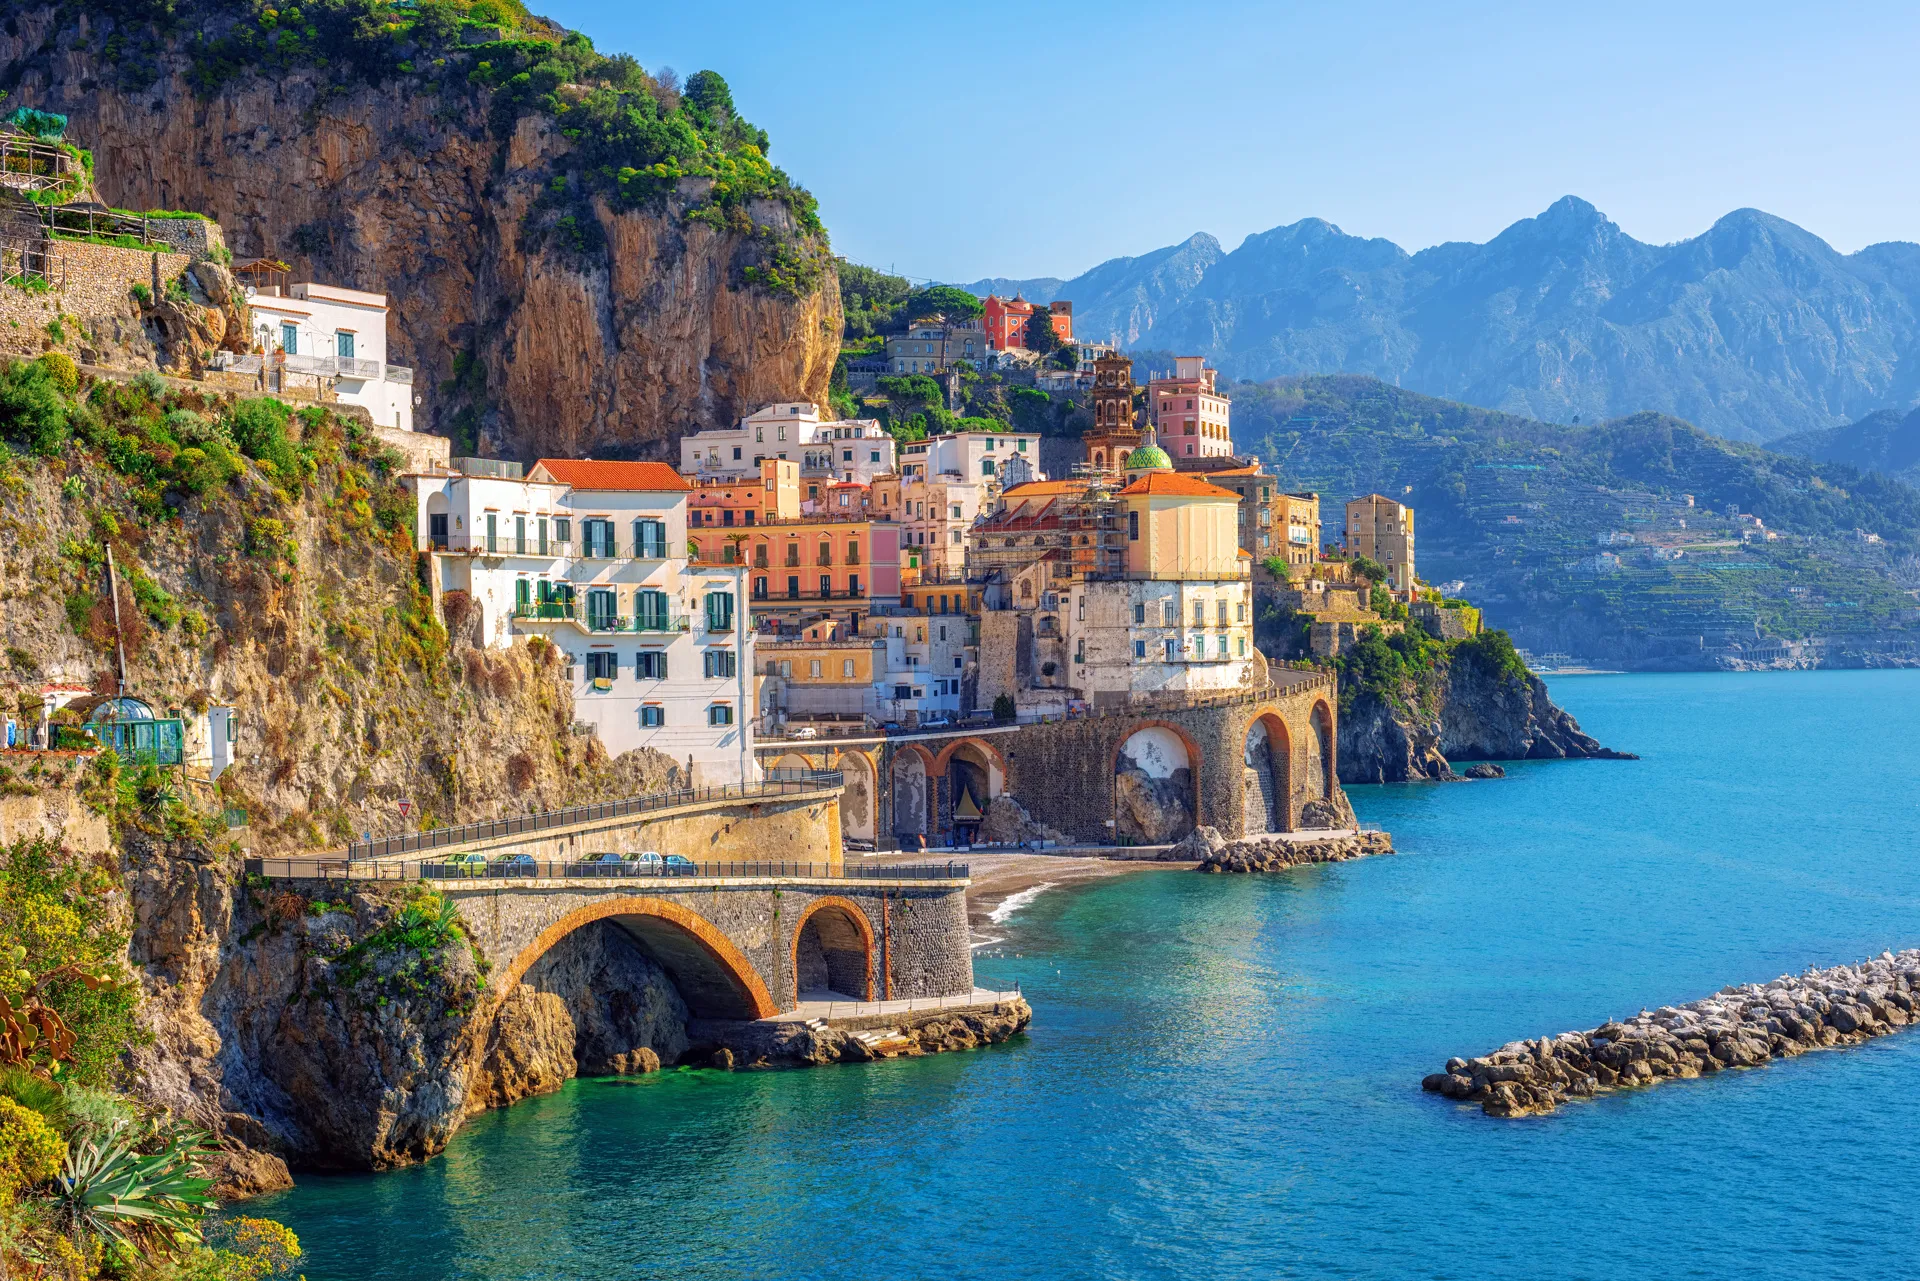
[532,0,1920,280]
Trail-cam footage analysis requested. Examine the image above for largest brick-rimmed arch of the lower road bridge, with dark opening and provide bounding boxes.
[497,895,780,1018]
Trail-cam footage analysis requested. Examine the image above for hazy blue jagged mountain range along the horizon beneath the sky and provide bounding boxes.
[1021,196,1920,442]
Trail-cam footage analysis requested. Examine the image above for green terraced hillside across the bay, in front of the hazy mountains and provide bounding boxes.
[1227,375,1920,666]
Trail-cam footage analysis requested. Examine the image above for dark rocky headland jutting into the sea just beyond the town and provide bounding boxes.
[1340,657,1632,784]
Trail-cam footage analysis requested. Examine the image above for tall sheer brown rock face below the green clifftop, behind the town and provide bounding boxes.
[0,6,841,457]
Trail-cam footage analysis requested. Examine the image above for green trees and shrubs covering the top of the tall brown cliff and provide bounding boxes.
[61,0,829,286]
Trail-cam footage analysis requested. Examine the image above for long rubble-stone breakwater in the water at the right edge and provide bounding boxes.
[1421,949,1920,1116]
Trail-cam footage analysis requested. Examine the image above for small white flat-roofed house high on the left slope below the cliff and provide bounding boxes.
[232,282,413,432]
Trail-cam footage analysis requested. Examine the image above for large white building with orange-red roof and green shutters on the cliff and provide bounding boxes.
[407,459,756,786]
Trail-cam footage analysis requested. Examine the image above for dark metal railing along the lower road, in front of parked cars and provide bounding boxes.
[246,855,972,882]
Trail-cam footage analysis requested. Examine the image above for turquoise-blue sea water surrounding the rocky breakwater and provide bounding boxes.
[252,672,1920,1281]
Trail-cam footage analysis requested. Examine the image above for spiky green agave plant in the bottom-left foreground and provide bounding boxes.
[54,1125,217,1254]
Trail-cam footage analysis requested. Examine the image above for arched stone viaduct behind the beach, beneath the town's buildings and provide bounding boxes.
[756,670,1352,849]
